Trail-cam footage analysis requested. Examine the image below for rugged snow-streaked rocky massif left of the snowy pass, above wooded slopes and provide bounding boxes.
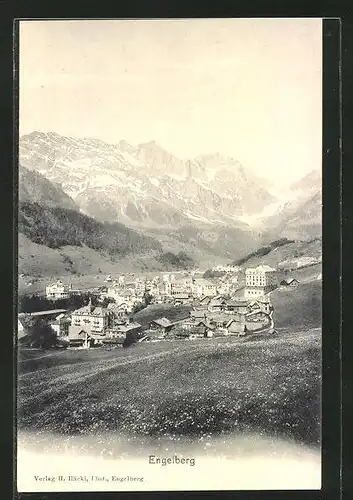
[19,132,274,228]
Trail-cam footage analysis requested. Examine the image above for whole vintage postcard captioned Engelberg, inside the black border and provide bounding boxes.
[15,18,323,492]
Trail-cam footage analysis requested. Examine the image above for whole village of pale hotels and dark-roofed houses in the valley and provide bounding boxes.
[18,265,298,349]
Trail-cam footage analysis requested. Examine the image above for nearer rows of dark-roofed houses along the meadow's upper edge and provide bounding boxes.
[24,296,274,348]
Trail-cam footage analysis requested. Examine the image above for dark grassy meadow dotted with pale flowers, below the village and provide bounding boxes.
[18,330,321,445]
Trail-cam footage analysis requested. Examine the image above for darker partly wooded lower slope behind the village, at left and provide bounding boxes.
[19,171,256,275]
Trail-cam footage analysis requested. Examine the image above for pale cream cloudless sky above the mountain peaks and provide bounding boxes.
[19,18,322,186]
